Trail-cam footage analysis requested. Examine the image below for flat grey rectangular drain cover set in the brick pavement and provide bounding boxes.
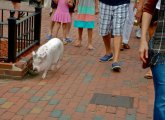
[90,93,134,108]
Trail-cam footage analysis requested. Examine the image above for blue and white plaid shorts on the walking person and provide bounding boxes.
[99,2,129,36]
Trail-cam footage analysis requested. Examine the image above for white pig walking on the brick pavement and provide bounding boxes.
[32,38,64,79]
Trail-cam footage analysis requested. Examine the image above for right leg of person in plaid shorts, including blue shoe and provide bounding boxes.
[112,4,129,71]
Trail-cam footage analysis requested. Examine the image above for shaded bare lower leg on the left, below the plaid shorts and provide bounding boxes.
[103,35,112,55]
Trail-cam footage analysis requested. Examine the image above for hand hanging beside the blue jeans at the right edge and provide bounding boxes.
[139,38,148,63]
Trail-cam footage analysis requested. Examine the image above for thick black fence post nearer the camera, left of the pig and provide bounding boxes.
[8,11,17,62]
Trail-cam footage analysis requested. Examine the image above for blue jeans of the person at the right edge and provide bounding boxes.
[151,60,165,120]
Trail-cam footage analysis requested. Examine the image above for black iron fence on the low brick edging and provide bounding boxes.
[0,7,42,62]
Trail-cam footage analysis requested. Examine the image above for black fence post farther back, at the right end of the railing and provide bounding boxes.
[34,6,42,45]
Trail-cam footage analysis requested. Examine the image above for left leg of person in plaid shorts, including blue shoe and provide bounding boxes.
[99,2,113,62]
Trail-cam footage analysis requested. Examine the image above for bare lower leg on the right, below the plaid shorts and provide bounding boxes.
[113,36,122,62]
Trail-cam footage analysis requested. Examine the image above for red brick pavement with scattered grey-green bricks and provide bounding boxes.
[0,1,154,120]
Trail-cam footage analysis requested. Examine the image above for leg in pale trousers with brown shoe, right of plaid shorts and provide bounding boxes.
[122,3,135,49]
